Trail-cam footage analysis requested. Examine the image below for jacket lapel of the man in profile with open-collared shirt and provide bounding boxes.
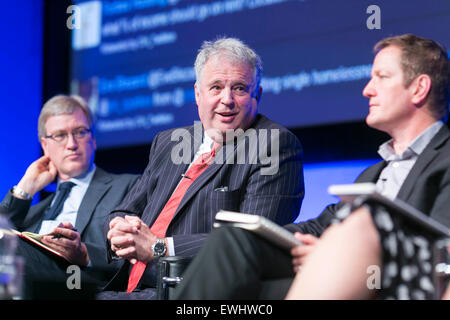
[397,124,450,200]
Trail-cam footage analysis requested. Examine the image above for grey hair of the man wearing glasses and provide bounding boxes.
[38,95,94,138]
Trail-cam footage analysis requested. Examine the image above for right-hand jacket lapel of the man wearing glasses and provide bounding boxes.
[75,168,112,234]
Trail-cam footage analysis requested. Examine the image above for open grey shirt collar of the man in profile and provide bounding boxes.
[378,121,444,161]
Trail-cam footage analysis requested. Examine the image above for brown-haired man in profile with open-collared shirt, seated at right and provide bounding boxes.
[175,34,450,299]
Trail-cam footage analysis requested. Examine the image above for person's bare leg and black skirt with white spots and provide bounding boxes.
[287,199,446,300]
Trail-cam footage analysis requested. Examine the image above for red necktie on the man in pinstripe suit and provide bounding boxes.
[127,142,219,293]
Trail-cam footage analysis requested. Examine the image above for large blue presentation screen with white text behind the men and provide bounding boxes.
[68,0,450,148]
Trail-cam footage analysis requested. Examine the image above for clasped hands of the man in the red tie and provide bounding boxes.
[107,216,157,264]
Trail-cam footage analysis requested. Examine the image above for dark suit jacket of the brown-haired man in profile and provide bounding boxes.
[285,125,450,236]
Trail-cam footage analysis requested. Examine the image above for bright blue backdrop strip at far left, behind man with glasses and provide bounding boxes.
[0,0,43,197]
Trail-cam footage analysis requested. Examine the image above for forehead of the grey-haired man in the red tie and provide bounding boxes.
[202,56,254,83]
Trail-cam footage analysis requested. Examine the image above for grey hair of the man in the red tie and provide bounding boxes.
[194,38,263,89]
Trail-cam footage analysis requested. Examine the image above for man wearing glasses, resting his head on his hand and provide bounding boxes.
[0,95,137,298]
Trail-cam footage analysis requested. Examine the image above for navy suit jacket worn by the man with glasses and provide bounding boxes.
[0,167,138,277]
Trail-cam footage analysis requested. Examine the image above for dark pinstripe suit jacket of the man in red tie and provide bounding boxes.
[103,115,304,289]
